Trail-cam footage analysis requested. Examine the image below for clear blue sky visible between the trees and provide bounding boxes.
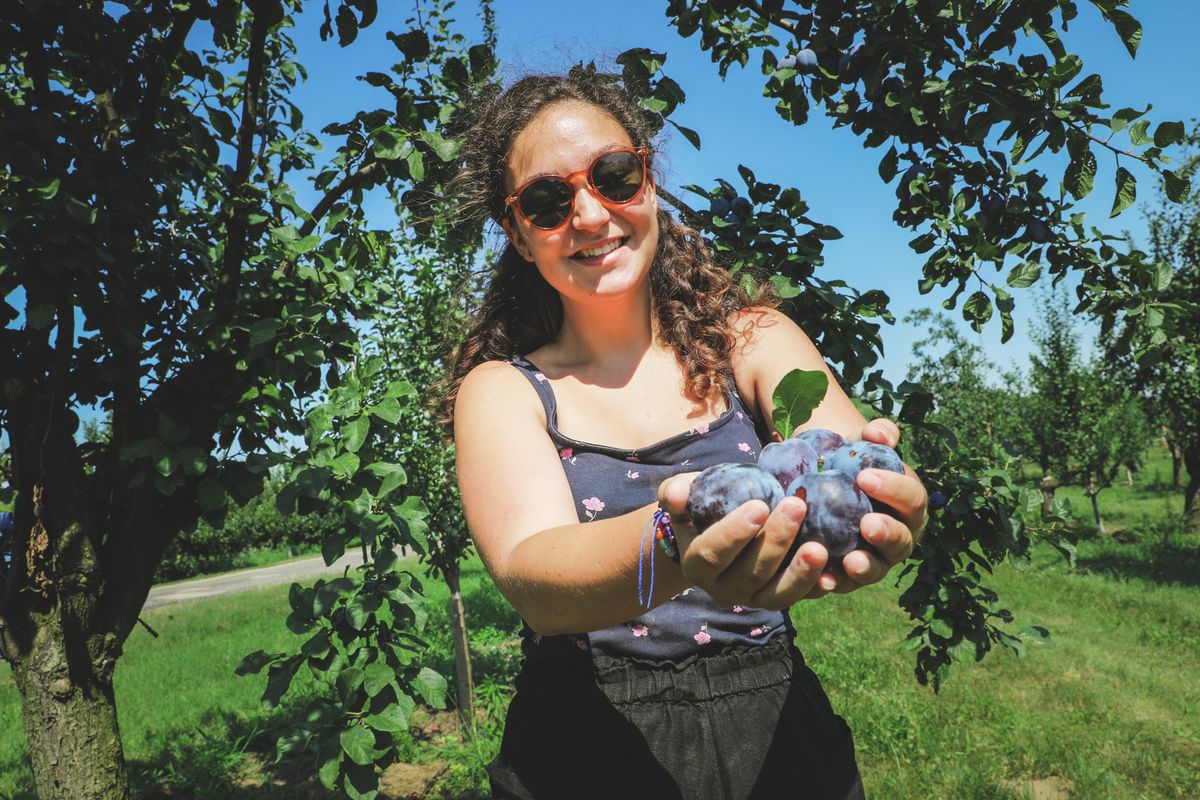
[296,0,1200,388]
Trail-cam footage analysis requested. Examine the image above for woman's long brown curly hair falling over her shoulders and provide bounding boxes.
[442,67,779,428]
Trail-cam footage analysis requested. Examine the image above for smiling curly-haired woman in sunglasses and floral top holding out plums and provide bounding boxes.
[448,70,925,798]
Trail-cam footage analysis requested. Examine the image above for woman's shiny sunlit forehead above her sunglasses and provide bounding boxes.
[505,101,632,187]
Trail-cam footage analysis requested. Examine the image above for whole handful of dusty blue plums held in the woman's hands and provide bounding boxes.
[688,428,904,565]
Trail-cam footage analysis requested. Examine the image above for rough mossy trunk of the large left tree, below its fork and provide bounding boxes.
[13,614,130,800]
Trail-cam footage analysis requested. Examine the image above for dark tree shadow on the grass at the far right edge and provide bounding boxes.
[1075,529,1200,587]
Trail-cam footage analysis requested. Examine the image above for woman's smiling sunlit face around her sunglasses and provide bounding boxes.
[503,101,659,300]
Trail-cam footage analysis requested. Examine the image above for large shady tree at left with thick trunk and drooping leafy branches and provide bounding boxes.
[0,0,491,800]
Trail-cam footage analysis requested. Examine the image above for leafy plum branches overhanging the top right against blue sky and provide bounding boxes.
[667,0,1188,362]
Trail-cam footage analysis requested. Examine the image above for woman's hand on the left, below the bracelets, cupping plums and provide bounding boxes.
[659,473,838,609]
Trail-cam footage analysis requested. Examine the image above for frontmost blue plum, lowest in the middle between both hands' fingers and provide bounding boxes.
[787,471,875,567]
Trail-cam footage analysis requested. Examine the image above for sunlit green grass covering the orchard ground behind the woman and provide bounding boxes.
[0,453,1200,800]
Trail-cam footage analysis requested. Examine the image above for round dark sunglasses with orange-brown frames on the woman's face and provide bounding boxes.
[504,148,650,230]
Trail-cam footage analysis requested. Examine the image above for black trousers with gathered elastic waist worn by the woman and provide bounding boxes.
[488,634,864,800]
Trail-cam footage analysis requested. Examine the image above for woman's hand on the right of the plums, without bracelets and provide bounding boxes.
[809,417,929,597]
